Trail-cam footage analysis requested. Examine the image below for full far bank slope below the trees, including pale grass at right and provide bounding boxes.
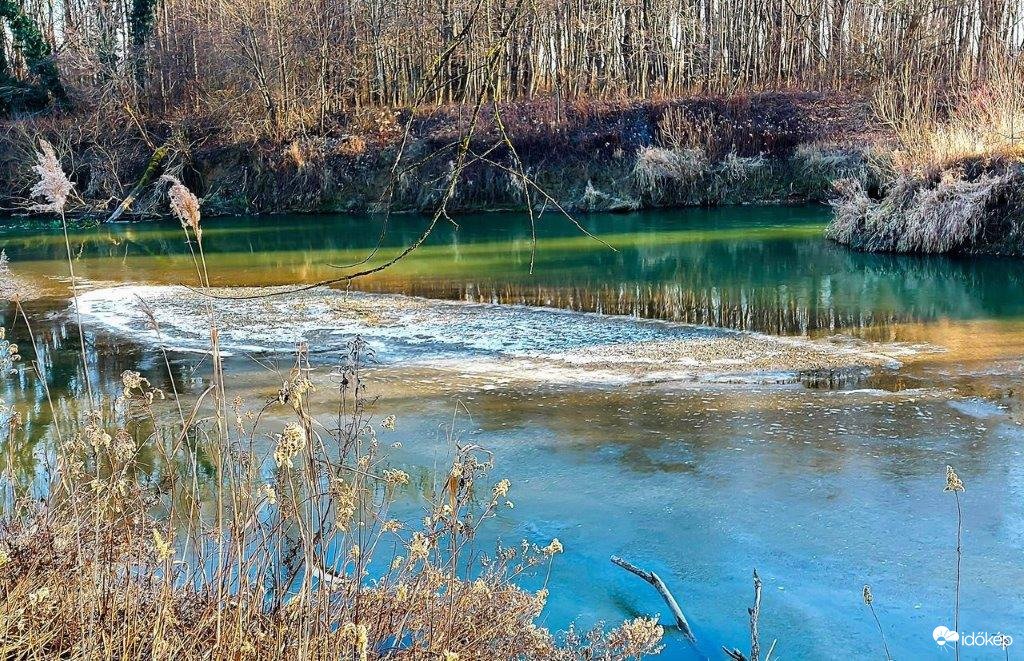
[8,89,1024,256]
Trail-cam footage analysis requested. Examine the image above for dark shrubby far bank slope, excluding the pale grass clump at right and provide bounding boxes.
[0,92,883,218]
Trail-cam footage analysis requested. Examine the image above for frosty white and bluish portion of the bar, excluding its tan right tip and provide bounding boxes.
[79,285,732,357]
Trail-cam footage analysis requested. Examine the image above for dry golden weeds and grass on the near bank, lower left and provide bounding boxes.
[0,346,662,661]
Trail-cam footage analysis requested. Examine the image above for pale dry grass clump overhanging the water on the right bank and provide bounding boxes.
[827,68,1024,254]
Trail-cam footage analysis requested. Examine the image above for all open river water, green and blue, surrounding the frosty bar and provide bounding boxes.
[0,207,1024,658]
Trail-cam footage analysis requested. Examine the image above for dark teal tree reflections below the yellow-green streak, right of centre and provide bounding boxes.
[360,240,1024,335]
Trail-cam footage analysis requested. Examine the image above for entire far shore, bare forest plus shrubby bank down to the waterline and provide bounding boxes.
[0,0,1024,253]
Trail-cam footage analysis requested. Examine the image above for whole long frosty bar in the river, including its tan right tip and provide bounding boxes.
[79,285,901,383]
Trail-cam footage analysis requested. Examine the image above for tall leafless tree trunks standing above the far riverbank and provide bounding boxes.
[0,0,1024,125]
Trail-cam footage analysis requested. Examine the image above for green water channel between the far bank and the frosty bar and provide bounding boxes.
[6,207,1024,334]
